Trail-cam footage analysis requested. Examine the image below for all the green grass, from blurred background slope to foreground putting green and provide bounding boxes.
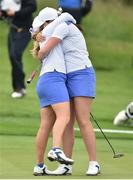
[0,0,133,179]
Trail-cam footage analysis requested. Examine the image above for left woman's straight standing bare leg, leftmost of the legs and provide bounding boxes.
[36,106,55,163]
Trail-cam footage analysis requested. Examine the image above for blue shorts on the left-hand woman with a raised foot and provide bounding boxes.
[36,71,69,108]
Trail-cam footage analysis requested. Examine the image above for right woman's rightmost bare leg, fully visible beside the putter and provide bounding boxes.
[74,97,96,161]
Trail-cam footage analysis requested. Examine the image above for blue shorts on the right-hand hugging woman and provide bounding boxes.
[66,67,96,98]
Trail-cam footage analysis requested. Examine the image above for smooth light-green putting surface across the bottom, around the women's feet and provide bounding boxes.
[0,136,133,179]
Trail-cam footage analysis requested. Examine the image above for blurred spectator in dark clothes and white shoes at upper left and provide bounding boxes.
[0,0,36,98]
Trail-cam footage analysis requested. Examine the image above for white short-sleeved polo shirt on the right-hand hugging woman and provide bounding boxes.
[52,22,92,73]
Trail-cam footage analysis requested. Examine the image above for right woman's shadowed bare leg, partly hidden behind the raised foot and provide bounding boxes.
[63,101,75,158]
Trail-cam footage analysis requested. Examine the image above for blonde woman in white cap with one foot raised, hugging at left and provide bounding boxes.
[32,8,74,176]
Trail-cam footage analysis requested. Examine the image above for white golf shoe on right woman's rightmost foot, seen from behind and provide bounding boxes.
[86,161,100,176]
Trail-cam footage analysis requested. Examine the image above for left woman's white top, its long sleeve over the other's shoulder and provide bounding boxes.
[40,13,76,76]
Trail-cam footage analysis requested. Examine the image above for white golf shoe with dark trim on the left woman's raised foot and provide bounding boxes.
[48,148,74,165]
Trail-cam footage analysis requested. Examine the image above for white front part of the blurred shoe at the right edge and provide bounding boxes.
[114,110,128,125]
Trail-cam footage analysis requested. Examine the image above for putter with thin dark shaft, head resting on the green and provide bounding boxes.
[90,113,124,158]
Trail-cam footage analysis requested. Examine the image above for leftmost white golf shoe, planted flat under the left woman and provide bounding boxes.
[33,165,53,176]
